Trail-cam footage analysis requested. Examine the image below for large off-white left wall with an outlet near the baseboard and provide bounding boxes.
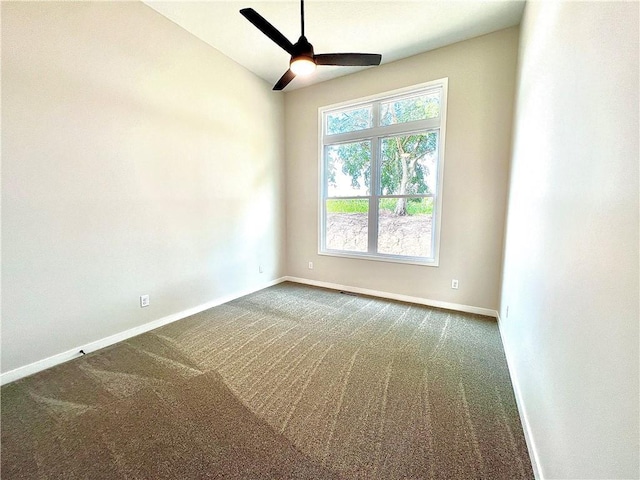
[2,2,284,372]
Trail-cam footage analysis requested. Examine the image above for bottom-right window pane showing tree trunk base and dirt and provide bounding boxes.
[378,197,433,257]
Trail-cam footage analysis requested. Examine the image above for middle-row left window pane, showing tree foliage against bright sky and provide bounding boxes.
[325,142,371,197]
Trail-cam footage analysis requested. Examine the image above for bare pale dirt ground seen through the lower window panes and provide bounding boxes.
[326,212,432,257]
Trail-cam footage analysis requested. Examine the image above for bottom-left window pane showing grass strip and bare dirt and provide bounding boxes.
[325,199,369,252]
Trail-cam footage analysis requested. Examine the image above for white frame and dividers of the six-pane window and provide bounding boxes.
[318,78,449,267]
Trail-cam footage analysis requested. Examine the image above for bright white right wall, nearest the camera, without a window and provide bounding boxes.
[500,2,640,479]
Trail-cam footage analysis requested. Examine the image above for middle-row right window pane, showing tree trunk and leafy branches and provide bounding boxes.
[380,131,438,195]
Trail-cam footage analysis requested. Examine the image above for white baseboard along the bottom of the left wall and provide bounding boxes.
[0,277,285,385]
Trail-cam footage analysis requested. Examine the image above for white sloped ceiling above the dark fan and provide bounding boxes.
[144,0,524,90]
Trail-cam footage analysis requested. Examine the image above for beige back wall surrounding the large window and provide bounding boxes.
[285,28,518,309]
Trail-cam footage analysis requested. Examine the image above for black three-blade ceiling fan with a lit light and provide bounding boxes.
[240,0,382,90]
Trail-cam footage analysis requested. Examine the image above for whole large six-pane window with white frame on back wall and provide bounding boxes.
[319,78,447,266]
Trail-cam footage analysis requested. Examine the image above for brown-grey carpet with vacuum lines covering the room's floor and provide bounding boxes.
[1,283,533,480]
